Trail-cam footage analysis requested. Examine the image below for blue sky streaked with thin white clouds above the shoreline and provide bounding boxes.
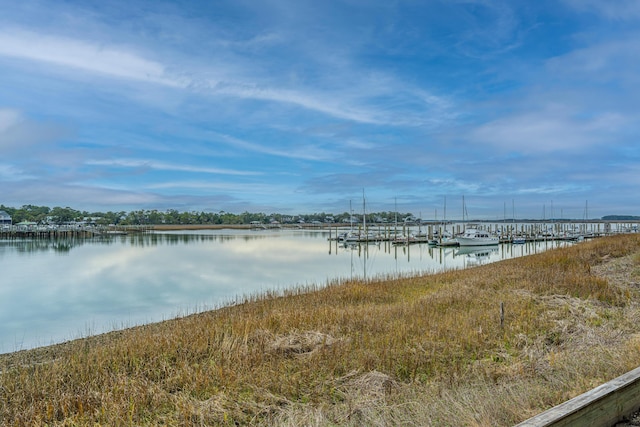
[0,0,640,219]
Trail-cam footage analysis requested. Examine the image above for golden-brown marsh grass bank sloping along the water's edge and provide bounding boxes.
[0,235,640,426]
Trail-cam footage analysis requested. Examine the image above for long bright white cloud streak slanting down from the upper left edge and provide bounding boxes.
[0,29,446,129]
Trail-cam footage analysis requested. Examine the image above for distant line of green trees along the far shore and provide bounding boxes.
[0,205,417,225]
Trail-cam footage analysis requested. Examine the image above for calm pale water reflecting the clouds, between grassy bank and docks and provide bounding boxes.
[0,230,560,353]
